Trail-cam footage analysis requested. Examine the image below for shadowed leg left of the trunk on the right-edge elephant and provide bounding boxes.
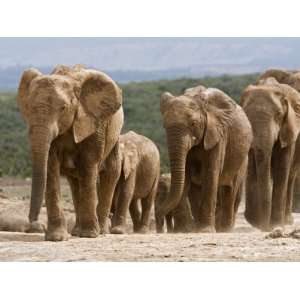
[244,150,259,227]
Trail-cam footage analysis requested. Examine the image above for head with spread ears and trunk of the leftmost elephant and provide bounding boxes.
[18,66,122,222]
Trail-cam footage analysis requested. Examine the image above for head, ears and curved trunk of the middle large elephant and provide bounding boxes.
[159,86,236,216]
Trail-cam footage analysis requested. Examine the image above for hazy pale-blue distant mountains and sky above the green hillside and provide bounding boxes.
[0,38,300,89]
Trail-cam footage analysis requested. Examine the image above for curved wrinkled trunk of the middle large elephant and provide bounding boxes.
[161,127,190,216]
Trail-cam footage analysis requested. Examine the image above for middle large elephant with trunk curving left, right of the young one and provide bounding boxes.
[158,86,252,232]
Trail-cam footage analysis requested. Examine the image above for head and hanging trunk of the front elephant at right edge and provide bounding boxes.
[241,82,300,229]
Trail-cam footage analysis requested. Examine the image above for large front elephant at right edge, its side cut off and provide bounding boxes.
[241,77,300,231]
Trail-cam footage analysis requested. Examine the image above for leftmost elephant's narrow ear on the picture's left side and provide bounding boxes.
[17,68,42,119]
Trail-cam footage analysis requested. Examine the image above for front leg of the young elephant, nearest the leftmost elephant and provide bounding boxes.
[111,173,135,234]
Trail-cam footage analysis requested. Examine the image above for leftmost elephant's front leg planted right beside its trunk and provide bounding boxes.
[45,151,69,241]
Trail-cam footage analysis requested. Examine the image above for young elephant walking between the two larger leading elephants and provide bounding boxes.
[111,131,160,234]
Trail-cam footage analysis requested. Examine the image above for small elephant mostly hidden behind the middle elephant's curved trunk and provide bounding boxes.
[155,173,194,233]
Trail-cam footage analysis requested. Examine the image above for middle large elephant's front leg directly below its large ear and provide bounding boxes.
[196,144,222,232]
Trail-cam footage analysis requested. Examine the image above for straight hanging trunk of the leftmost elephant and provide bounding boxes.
[29,127,51,223]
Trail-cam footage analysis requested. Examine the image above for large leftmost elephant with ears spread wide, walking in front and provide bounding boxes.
[18,65,123,241]
